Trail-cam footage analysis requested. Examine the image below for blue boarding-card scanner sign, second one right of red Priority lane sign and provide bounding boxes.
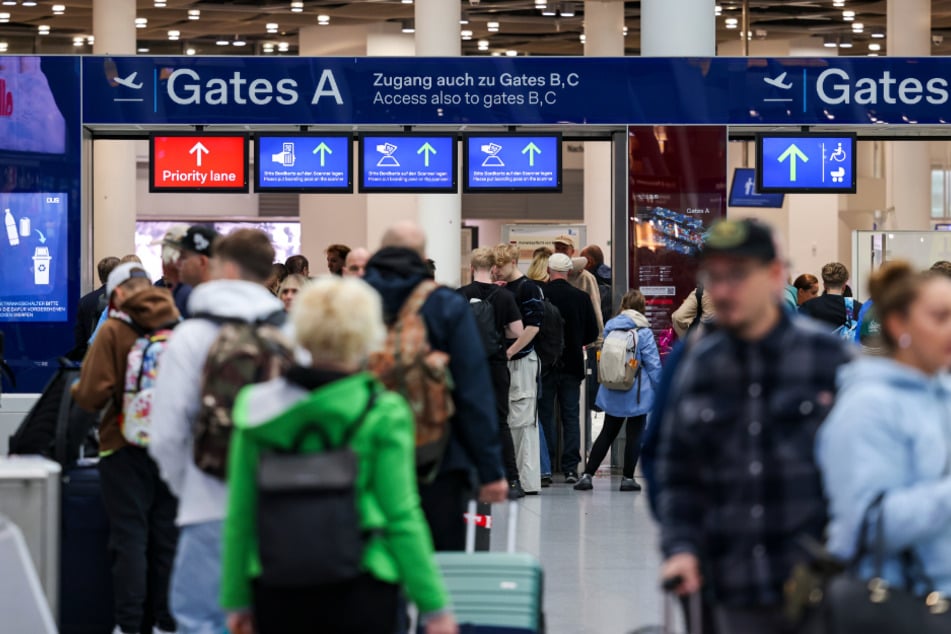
[360,134,458,193]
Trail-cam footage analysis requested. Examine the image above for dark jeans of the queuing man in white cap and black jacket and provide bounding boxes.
[538,370,581,473]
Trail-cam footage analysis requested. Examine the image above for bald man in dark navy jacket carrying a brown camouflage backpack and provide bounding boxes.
[364,223,509,550]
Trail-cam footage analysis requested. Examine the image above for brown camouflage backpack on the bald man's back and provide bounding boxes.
[369,280,455,482]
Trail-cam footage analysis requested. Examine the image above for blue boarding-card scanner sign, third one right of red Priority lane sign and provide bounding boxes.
[463,134,561,192]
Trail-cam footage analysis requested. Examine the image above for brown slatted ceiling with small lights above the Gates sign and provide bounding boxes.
[7,0,951,56]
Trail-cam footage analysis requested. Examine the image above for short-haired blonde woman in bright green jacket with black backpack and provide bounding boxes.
[221,277,457,634]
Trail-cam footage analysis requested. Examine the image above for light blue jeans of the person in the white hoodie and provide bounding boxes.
[171,521,227,634]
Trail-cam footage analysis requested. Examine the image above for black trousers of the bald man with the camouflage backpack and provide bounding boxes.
[419,471,472,551]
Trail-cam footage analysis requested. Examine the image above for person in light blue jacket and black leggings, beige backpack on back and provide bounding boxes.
[575,290,661,491]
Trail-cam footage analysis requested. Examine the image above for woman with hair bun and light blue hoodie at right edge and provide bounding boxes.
[817,262,951,595]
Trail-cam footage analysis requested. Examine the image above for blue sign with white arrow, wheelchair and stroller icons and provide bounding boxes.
[756,134,855,194]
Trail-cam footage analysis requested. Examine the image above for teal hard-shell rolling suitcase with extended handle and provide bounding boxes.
[436,502,545,634]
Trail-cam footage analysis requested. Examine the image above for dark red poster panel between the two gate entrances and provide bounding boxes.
[628,126,727,356]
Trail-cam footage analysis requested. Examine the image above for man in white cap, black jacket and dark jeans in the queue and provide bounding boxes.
[538,253,601,484]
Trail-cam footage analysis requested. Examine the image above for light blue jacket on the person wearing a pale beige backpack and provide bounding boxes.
[595,310,661,418]
